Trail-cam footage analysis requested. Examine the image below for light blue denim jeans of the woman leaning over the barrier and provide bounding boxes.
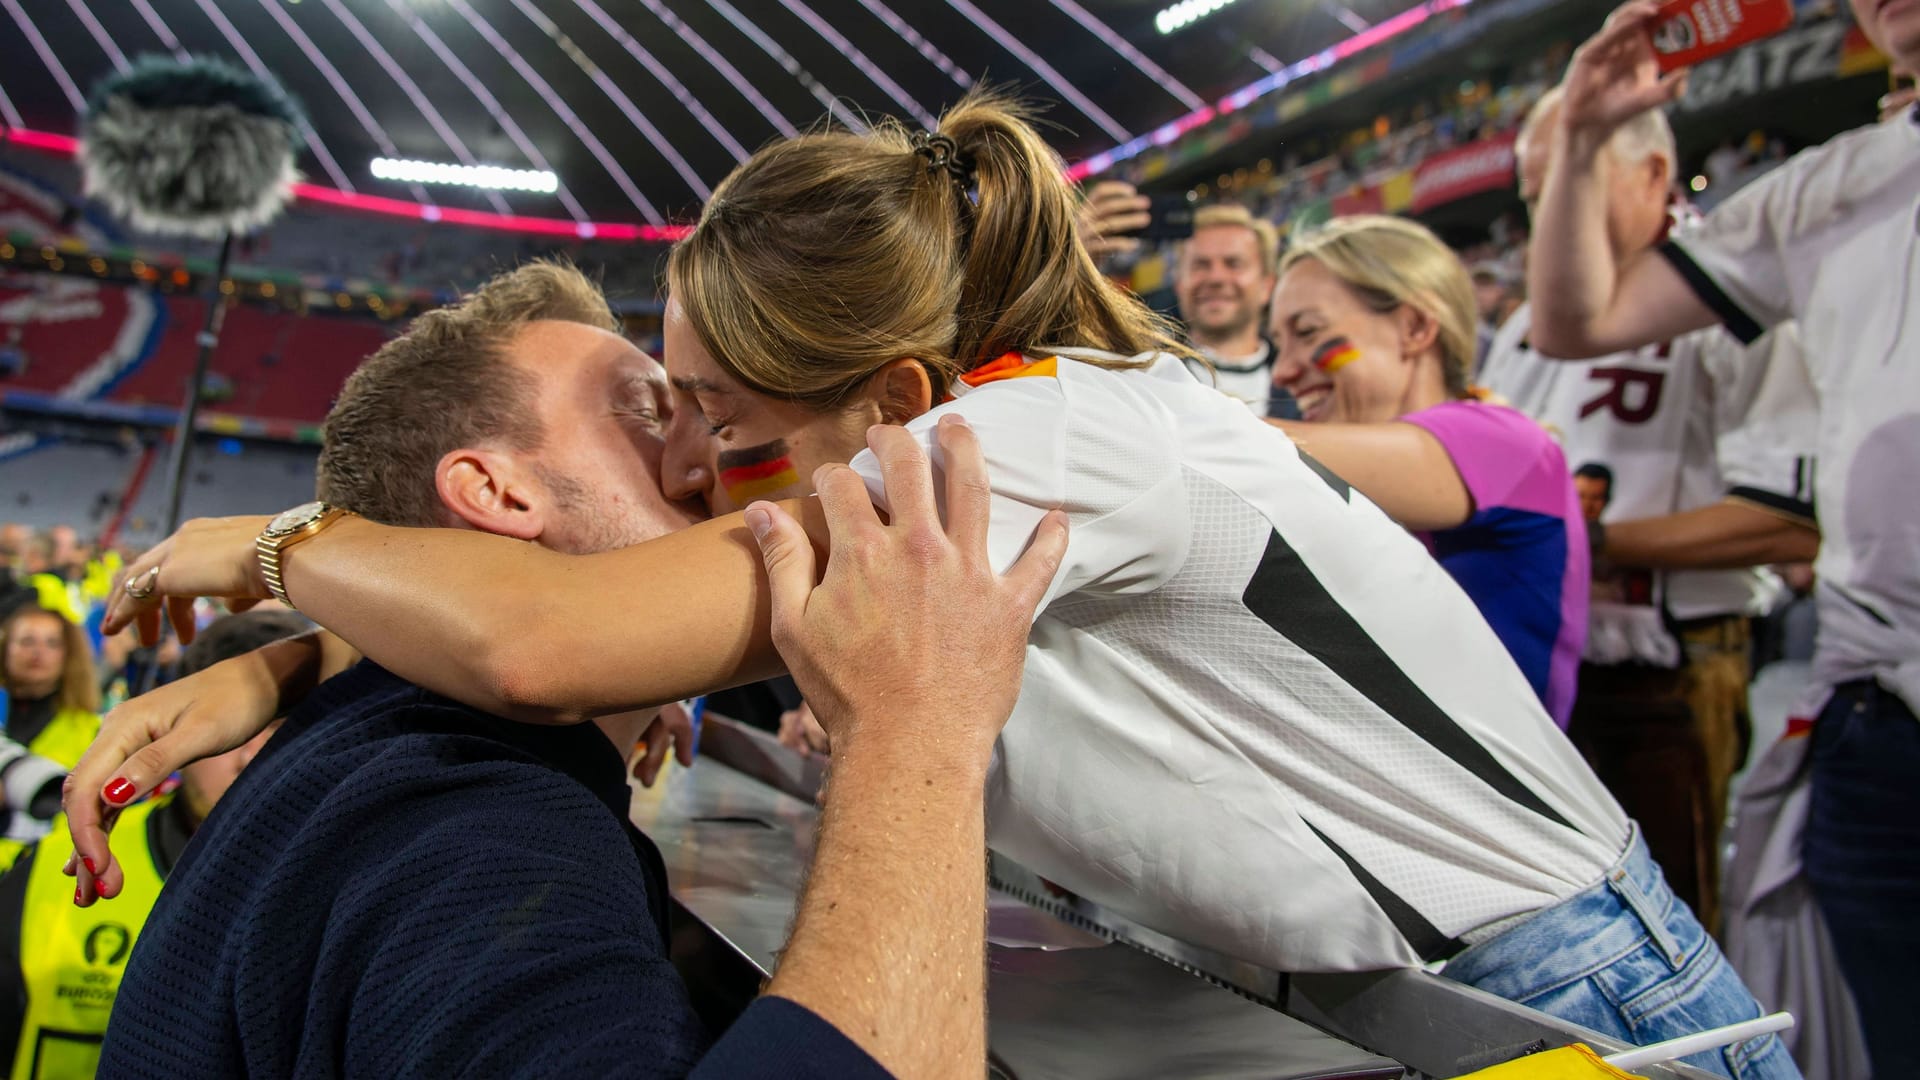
[1440,826,1799,1080]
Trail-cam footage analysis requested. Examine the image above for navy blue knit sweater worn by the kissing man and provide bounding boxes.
[100,663,885,1080]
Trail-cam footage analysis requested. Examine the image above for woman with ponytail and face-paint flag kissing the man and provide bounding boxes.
[77,94,1764,1076]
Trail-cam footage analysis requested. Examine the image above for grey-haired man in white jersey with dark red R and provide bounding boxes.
[1482,90,1820,930]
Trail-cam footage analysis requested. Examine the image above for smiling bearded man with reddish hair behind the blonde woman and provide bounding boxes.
[1173,206,1300,419]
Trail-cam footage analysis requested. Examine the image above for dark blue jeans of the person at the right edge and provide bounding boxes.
[1801,680,1920,1080]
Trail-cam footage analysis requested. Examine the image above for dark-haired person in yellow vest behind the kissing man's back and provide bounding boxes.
[0,609,313,1078]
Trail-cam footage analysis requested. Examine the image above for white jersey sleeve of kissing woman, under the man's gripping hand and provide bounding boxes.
[851,377,1190,607]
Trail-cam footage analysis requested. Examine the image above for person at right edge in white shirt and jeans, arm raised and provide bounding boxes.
[1530,0,1920,1076]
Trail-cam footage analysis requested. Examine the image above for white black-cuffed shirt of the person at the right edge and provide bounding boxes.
[1663,108,1920,709]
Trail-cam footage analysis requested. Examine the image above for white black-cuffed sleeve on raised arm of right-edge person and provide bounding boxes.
[1661,137,1843,344]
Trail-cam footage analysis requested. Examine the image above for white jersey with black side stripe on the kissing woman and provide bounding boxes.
[854,352,1628,970]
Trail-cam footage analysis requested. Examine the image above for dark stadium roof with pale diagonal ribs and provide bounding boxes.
[0,0,1421,225]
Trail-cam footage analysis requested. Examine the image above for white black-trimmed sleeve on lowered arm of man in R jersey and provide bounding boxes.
[1703,321,1820,521]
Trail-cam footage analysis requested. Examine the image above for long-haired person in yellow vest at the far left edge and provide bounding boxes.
[0,603,100,867]
